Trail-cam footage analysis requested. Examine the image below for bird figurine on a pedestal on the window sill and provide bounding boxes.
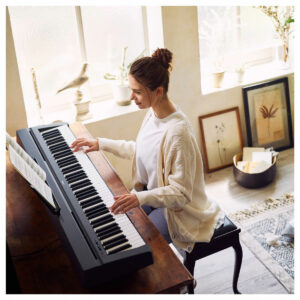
[57,63,92,121]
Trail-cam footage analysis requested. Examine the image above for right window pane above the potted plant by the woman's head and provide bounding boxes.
[81,6,145,86]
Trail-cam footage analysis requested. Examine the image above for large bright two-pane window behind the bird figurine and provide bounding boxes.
[9,6,146,124]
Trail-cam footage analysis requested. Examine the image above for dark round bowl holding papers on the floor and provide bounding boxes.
[233,153,277,189]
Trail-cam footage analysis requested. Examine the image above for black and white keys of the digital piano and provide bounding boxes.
[42,125,145,254]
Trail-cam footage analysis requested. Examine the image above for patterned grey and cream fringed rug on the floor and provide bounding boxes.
[229,194,294,294]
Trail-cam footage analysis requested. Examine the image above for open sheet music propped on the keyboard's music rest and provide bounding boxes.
[6,134,56,208]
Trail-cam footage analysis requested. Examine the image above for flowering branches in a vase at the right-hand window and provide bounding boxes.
[258,6,295,63]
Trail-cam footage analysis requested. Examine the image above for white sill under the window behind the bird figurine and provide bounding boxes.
[43,99,139,124]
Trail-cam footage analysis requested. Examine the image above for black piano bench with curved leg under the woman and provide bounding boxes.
[184,216,243,294]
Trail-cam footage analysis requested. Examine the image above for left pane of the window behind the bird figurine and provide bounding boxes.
[9,6,81,122]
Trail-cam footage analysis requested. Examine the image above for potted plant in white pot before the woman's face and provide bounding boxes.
[104,46,145,105]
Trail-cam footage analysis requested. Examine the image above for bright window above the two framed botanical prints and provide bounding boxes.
[198,6,294,89]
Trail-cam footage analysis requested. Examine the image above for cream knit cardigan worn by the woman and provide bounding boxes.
[98,111,224,252]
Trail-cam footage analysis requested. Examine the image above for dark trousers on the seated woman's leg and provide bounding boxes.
[142,204,172,244]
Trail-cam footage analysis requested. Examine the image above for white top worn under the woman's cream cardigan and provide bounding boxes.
[136,109,180,190]
